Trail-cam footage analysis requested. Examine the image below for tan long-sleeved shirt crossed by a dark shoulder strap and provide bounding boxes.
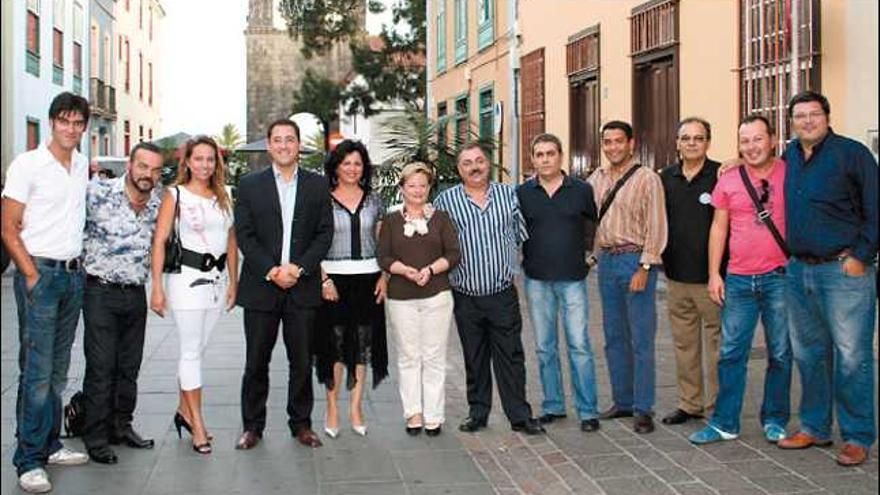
[587,164,667,265]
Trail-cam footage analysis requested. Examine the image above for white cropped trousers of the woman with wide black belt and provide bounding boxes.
[171,308,223,390]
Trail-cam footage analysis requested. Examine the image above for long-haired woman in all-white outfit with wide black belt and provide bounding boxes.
[150,136,238,454]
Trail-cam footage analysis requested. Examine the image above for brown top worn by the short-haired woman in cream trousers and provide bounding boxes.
[379,209,461,299]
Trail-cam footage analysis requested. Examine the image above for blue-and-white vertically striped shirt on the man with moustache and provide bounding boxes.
[434,182,528,296]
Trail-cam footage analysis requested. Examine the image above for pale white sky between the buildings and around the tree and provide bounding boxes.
[158,0,391,141]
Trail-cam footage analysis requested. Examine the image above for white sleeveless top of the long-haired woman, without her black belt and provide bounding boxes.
[165,186,233,310]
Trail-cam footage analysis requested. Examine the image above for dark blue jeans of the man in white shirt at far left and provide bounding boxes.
[12,266,84,475]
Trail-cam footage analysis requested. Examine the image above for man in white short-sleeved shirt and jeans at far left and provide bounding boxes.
[2,93,89,493]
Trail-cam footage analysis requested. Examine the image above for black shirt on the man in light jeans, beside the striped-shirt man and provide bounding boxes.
[516,176,597,281]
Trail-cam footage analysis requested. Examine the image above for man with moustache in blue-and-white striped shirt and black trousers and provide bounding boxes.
[434,143,544,435]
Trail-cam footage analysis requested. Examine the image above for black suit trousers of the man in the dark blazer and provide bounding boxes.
[241,308,315,435]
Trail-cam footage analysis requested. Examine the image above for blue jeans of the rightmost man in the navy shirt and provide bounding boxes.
[786,259,877,448]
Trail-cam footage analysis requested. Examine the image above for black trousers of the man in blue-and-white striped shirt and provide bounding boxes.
[453,286,532,423]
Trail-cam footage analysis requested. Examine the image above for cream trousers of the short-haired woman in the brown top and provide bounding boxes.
[385,290,452,423]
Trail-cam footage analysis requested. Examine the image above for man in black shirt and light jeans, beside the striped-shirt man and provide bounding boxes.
[517,134,599,432]
